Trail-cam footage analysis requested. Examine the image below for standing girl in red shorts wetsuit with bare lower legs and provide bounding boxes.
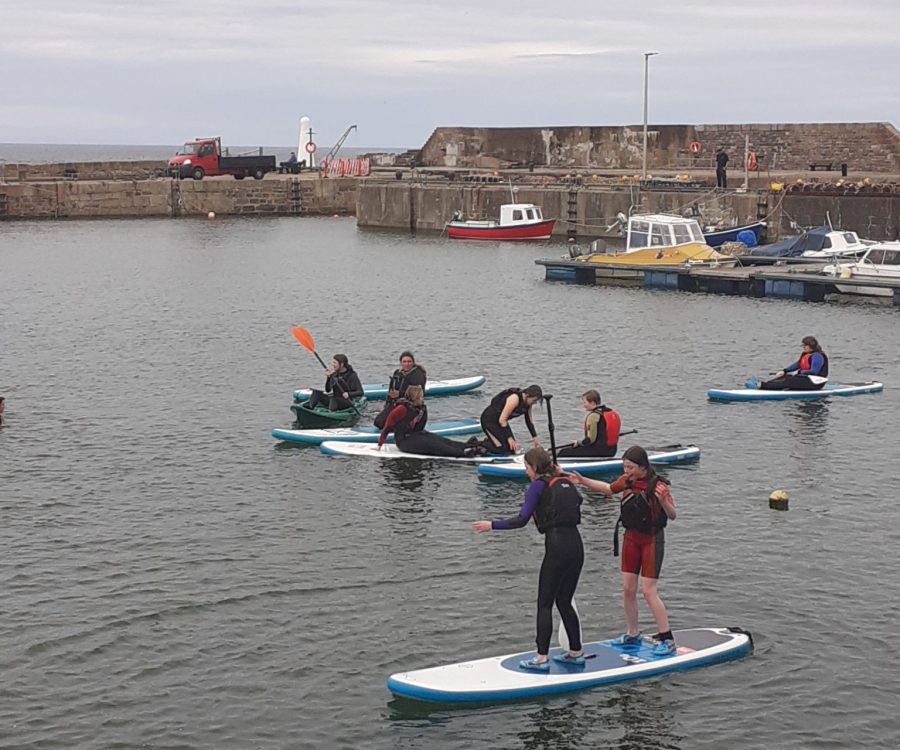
[566,445,675,656]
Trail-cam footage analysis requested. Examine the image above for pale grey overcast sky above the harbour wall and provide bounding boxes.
[0,0,900,147]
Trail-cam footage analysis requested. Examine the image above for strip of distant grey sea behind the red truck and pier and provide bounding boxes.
[0,143,407,164]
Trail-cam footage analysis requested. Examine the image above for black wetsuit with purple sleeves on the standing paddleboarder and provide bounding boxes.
[491,477,584,654]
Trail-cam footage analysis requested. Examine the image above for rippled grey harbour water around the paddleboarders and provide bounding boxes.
[0,218,900,750]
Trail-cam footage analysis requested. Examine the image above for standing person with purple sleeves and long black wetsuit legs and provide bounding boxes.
[472,447,584,672]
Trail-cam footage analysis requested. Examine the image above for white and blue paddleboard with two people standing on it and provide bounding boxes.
[387,628,753,703]
